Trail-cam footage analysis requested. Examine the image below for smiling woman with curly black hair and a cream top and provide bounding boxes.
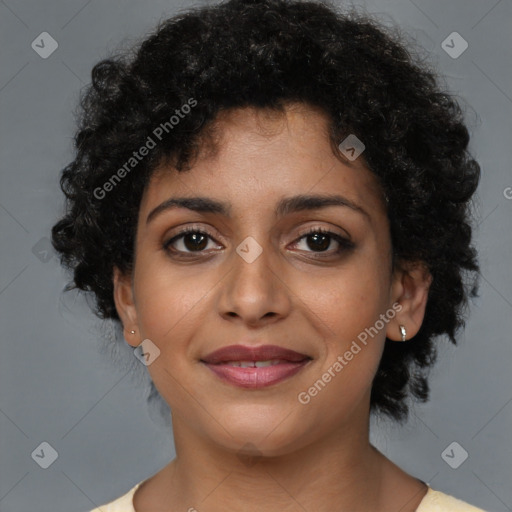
[53,0,480,512]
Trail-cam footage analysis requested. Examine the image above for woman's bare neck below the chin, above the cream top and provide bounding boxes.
[148,417,392,512]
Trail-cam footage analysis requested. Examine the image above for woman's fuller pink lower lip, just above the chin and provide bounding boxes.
[204,359,310,388]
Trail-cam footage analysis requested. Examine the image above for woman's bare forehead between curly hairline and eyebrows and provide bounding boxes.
[141,104,384,221]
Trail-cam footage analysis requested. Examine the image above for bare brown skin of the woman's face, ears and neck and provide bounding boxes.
[114,104,431,512]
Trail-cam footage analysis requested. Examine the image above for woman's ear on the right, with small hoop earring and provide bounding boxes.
[386,262,432,341]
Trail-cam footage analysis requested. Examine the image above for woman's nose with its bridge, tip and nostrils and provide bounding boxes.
[219,234,289,323]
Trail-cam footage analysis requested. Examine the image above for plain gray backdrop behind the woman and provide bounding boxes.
[0,0,512,512]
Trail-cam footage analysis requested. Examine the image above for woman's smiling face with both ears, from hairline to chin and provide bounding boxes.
[115,105,426,455]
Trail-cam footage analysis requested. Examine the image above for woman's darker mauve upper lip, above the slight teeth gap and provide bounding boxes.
[201,345,311,364]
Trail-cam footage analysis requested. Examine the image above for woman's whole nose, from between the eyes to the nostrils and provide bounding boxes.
[218,239,291,327]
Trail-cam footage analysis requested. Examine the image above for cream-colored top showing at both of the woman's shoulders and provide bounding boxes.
[91,482,485,512]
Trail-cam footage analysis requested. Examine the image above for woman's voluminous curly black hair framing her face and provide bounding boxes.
[52,0,480,422]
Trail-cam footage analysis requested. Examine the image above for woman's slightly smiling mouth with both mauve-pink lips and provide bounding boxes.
[200,345,312,388]
